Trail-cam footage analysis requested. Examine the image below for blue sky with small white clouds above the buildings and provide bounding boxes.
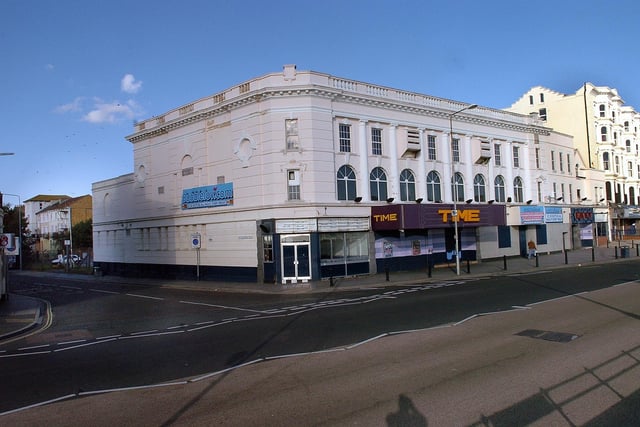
[0,0,640,205]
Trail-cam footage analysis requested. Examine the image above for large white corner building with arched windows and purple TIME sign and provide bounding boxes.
[93,65,602,284]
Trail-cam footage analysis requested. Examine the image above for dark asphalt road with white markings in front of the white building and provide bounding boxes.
[0,263,639,422]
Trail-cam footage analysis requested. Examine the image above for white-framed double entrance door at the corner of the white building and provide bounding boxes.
[280,234,311,283]
